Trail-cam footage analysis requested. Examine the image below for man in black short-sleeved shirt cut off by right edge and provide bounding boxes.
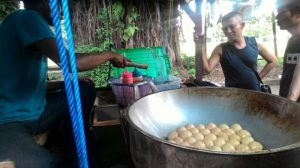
[276,0,300,102]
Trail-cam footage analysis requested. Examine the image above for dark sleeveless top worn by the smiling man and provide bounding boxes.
[220,37,261,91]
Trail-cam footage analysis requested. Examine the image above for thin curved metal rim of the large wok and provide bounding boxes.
[125,87,300,156]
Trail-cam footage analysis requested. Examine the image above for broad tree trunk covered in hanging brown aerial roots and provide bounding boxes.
[72,0,181,68]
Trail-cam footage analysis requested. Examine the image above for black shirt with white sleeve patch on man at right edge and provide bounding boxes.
[279,35,300,100]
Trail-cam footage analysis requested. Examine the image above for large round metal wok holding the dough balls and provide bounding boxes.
[125,88,300,168]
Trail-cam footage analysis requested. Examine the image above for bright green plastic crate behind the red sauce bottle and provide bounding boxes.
[111,47,170,84]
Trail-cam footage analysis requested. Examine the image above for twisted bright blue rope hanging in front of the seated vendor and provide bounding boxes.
[49,0,89,168]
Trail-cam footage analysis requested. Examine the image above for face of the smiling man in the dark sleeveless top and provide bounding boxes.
[222,17,244,41]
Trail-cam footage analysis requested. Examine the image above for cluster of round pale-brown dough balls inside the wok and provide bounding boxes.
[167,122,263,152]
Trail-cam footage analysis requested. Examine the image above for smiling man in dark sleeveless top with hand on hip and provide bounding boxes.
[202,12,277,91]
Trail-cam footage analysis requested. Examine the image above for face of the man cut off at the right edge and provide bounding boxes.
[276,8,300,30]
